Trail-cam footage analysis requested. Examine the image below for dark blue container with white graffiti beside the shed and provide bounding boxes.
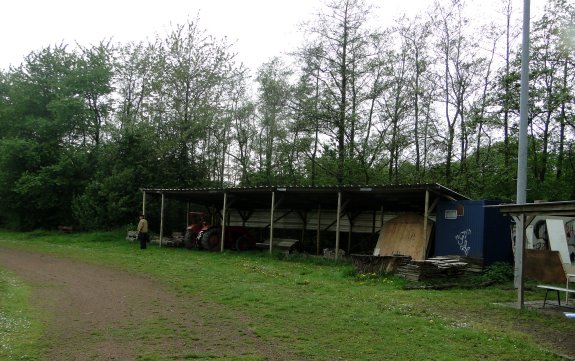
[434,200,513,266]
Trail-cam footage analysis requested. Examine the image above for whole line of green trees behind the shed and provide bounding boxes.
[0,0,575,229]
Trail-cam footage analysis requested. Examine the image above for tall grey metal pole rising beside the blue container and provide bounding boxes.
[515,0,531,309]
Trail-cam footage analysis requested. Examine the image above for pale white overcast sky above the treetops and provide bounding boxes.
[0,0,543,69]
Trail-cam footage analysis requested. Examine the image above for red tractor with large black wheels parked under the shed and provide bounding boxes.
[184,212,256,251]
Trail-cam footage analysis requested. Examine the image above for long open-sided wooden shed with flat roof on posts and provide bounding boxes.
[141,184,468,258]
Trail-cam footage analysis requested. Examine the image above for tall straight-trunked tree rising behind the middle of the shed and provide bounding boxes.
[303,0,378,184]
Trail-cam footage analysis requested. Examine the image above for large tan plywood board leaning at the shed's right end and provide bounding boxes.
[374,214,433,259]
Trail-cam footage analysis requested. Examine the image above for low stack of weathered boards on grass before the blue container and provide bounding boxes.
[397,257,468,281]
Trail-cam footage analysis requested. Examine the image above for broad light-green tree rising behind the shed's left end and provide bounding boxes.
[150,19,241,186]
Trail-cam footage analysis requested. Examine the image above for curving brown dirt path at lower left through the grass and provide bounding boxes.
[0,248,295,361]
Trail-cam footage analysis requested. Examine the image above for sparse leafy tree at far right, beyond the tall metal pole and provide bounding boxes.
[530,0,575,186]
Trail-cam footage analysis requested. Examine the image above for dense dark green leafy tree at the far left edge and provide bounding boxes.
[0,45,111,228]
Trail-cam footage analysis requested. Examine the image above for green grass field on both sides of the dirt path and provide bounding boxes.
[0,232,575,360]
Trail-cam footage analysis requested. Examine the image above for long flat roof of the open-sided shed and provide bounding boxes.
[142,183,469,214]
